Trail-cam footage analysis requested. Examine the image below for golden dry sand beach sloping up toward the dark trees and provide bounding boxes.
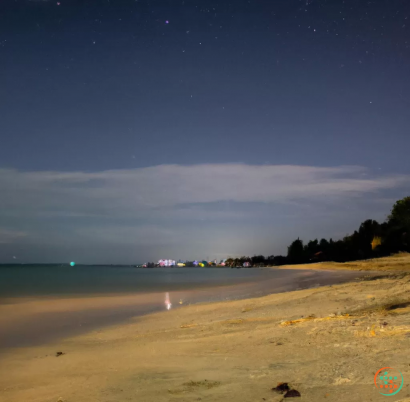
[0,256,410,402]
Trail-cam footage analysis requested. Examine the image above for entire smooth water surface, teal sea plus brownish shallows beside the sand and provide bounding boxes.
[0,265,369,351]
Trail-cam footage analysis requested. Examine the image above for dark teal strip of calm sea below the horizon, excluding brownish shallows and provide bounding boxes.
[0,265,322,297]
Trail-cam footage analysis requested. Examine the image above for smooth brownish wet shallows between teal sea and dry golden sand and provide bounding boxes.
[0,270,368,353]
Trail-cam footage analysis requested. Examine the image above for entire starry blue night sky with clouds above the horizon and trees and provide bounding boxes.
[0,0,410,263]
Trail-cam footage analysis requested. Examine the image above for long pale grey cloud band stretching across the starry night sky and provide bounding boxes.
[0,164,410,218]
